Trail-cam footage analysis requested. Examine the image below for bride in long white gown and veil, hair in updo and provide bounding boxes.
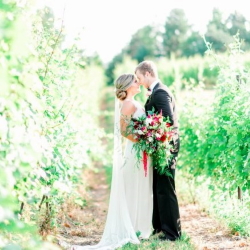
[71,74,153,250]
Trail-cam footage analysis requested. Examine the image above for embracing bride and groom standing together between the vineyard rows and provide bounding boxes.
[71,61,181,250]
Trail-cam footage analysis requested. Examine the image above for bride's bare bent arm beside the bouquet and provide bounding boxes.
[120,101,137,142]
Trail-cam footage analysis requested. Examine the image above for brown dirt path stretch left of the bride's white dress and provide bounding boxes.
[58,170,109,250]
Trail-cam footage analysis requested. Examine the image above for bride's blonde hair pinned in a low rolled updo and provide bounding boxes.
[115,74,135,101]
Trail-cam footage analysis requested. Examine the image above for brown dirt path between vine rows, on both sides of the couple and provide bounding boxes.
[59,168,250,250]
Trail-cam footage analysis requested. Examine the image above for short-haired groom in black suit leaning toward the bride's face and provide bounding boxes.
[135,61,181,241]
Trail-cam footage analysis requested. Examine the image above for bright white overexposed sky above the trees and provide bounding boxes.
[41,0,249,63]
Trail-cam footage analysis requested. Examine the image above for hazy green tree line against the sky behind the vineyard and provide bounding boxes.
[106,8,250,85]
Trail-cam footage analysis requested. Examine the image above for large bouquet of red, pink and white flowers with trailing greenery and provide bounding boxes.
[127,111,174,176]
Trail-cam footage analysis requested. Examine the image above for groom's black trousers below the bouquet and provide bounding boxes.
[153,137,181,241]
